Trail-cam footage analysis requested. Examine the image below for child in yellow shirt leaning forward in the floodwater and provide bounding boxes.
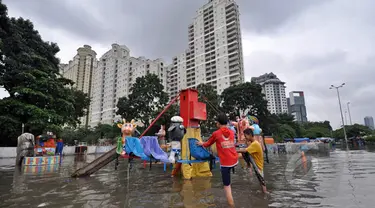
[238,128,268,194]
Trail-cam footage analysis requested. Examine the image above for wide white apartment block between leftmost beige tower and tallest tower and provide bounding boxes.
[90,44,167,127]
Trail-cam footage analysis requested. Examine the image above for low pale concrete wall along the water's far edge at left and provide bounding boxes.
[0,146,115,158]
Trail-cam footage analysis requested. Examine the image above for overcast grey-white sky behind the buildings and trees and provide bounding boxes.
[0,0,375,128]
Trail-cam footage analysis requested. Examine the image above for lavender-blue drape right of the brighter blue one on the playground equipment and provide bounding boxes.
[141,136,169,163]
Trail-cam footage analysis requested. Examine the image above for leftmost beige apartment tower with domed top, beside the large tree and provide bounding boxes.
[60,45,98,126]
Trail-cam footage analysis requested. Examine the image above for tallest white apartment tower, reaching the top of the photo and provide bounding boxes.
[168,0,244,97]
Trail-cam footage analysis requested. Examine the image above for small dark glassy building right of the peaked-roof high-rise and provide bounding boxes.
[287,91,307,123]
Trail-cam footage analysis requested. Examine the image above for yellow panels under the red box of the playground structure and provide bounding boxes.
[181,128,212,179]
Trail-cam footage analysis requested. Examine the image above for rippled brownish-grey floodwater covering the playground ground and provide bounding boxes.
[0,146,375,208]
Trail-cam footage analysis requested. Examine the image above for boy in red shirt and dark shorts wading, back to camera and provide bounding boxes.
[197,114,238,206]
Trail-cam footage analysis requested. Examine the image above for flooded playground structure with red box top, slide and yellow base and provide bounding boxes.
[72,89,212,179]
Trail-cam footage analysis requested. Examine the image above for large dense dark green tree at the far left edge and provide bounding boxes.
[0,1,89,143]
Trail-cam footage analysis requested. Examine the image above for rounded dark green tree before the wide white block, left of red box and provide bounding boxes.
[117,74,168,126]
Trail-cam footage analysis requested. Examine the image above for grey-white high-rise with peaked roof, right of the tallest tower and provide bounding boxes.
[251,72,288,114]
